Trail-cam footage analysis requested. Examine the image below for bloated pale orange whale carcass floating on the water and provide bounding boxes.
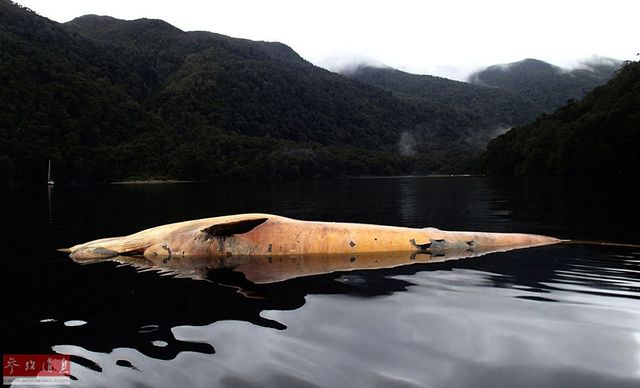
[64,213,561,260]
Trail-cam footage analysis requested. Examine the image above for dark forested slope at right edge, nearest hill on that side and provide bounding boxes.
[482,62,640,175]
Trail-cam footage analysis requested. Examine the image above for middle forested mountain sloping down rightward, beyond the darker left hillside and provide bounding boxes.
[60,16,510,159]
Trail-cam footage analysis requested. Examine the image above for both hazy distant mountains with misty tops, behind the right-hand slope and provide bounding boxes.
[350,58,622,126]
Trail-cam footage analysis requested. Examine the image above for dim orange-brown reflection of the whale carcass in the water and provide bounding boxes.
[74,245,540,284]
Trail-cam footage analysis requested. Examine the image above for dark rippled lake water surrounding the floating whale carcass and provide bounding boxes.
[0,177,640,387]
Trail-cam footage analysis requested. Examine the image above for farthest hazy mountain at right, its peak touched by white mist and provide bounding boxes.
[469,58,622,113]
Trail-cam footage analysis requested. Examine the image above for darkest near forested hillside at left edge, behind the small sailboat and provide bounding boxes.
[0,0,174,182]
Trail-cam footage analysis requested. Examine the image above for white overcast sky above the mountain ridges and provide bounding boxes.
[17,0,640,79]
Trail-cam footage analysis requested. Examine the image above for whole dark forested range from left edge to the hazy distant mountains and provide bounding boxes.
[0,0,624,185]
